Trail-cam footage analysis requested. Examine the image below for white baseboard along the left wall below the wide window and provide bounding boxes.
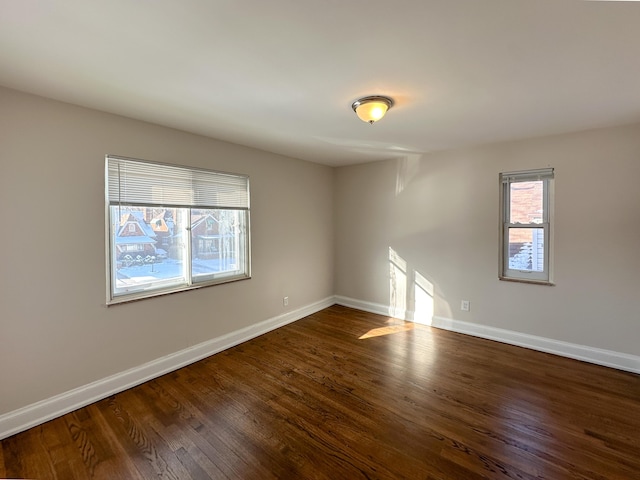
[0,297,335,440]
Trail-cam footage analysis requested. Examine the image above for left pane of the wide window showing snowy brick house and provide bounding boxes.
[109,206,187,295]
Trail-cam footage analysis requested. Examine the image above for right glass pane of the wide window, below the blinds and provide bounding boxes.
[191,208,247,282]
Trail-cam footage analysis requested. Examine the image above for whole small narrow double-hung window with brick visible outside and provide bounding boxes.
[500,168,553,284]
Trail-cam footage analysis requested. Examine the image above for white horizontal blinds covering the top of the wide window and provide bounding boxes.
[107,156,249,210]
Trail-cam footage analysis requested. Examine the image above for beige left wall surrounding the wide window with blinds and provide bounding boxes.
[0,89,333,414]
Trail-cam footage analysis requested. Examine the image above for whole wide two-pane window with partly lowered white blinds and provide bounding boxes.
[105,155,251,303]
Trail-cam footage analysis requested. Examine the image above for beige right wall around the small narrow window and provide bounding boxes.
[334,125,640,355]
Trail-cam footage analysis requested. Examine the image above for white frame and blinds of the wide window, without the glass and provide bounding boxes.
[105,155,251,305]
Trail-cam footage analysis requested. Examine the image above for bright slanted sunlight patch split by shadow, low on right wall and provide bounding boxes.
[389,247,434,325]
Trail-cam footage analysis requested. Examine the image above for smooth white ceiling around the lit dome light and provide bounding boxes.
[0,0,640,165]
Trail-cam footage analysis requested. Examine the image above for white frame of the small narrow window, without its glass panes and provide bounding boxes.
[499,168,554,285]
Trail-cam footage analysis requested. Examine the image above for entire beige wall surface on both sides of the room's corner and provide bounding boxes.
[0,84,640,415]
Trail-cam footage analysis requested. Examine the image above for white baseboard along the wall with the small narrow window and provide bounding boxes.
[336,295,640,374]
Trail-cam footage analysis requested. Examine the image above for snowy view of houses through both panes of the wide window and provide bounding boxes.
[111,207,246,293]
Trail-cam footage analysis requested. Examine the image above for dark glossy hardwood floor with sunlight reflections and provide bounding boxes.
[0,306,640,480]
